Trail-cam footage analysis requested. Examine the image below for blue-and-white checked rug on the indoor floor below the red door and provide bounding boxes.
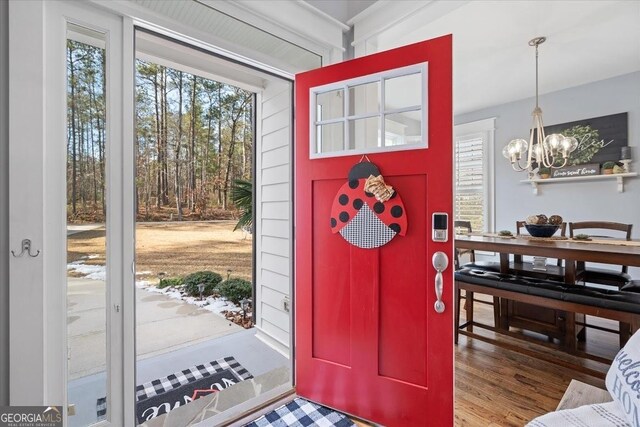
[245,397,355,427]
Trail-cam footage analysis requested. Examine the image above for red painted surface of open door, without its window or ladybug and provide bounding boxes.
[295,36,453,426]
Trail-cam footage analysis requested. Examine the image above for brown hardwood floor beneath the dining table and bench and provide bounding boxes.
[455,296,618,427]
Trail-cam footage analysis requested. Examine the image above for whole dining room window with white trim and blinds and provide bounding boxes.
[454,118,495,232]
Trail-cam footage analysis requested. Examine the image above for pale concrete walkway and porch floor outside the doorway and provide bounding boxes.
[68,278,290,427]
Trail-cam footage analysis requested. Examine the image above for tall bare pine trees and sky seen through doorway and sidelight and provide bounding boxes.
[67,41,254,222]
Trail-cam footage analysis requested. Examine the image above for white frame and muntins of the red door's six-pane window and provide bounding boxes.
[309,62,429,159]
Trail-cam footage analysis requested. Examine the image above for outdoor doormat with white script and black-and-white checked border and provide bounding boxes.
[96,357,253,424]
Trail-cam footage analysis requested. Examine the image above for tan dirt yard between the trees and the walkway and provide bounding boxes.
[67,221,252,281]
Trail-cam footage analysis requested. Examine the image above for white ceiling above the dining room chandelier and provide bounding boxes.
[309,0,640,114]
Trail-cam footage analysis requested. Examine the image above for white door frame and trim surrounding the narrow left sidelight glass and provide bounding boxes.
[9,1,135,426]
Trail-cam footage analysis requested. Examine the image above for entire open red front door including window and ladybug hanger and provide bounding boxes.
[295,36,454,426]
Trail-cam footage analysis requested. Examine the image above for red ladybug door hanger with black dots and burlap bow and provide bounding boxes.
[331,160,407,249]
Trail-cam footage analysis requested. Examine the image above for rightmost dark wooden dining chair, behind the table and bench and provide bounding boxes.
[569,221,633,346]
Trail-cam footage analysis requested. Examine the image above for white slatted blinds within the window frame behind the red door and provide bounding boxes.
[454,133,488,231]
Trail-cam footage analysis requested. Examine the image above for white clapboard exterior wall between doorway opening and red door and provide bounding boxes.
[254,77,293,357]
